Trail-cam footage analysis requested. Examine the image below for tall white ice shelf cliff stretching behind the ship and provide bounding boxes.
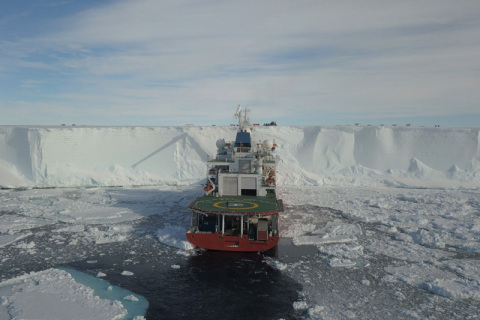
[0,126,480,187]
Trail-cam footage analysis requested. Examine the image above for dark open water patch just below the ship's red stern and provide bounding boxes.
[68,239,315,319]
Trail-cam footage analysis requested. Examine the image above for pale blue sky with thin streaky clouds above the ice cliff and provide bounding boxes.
[0,0,480,127]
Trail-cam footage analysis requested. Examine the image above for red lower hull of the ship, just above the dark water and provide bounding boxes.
[187,232,279,252]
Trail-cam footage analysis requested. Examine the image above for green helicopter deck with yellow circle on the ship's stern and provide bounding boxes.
[189,196,278,214]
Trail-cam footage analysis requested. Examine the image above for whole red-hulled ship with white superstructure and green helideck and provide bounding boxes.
[187,106,283,252]
